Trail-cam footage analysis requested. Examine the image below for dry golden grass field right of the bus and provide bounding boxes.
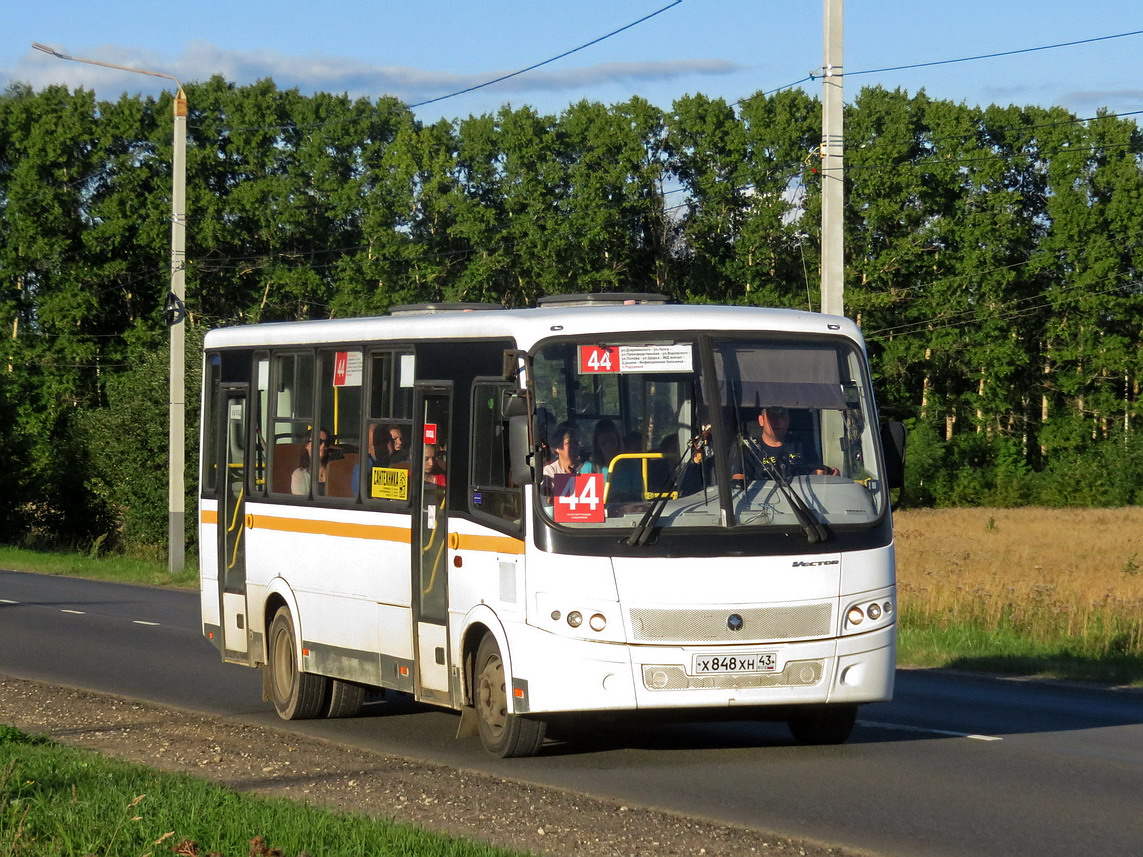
[894,507,1143,665]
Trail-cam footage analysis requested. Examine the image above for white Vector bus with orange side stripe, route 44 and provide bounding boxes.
[199,295,904,756]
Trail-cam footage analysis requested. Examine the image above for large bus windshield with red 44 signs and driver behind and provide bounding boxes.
[531,334,887,534]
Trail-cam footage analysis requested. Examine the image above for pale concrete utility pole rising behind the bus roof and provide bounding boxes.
[821,0,846,315]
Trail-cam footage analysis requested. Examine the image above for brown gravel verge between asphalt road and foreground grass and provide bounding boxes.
[0,676,861,857]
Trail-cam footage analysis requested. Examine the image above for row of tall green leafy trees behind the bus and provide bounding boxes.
[0,78,1143,550]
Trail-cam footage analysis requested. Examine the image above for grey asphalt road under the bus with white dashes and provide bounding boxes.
[0,571,1143,857]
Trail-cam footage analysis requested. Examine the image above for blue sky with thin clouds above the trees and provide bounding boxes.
[0,0,1143,121]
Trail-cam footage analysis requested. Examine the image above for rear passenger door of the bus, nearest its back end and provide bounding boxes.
[218,385,249,664]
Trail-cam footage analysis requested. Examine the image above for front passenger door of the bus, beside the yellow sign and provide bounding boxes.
[411,386,453,703]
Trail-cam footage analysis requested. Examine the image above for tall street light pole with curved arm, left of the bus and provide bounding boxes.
[32,42,186,574]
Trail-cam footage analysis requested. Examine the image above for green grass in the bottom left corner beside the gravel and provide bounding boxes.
[0,724,519,857]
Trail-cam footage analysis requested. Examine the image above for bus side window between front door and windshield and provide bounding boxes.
[469,381,523,527]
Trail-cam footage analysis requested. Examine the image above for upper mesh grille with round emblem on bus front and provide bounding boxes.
[631,601,833,644]
